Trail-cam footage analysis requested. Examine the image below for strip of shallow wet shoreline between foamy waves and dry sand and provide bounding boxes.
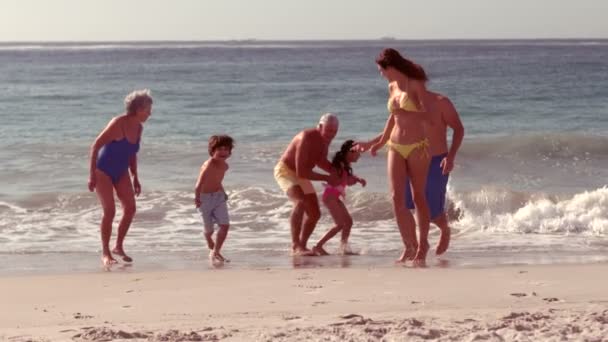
[0,251,608,279]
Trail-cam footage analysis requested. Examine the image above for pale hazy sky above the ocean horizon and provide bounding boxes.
[0,0,608,42]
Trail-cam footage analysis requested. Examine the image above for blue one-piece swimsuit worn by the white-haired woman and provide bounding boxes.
[96,137,139,184]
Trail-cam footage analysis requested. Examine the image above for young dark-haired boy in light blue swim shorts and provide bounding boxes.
[194,135,234,263]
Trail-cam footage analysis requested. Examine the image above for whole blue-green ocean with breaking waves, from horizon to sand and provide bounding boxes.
[0,40,608,274]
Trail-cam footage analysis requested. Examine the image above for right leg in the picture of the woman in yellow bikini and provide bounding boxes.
[407,148,431,262]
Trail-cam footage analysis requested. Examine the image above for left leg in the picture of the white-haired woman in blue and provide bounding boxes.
[95,170,116,266]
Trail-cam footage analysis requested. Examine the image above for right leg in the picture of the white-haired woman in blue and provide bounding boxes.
[112,172,135,262]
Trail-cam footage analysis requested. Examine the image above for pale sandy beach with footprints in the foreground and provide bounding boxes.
[0,264,608,341]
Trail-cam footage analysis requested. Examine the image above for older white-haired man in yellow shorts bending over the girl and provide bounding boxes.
[274,113,339,255]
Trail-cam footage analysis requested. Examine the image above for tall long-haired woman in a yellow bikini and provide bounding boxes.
[370,49,430,264]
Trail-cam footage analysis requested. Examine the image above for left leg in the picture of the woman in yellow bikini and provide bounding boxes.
[387,149,418,262]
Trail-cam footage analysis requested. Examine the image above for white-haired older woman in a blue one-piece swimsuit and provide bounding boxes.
[89,89,152,266]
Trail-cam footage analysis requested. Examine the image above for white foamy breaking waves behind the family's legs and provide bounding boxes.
[0,186,608,253]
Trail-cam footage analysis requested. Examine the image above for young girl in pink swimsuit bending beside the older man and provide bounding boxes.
[312,140,366,255]
